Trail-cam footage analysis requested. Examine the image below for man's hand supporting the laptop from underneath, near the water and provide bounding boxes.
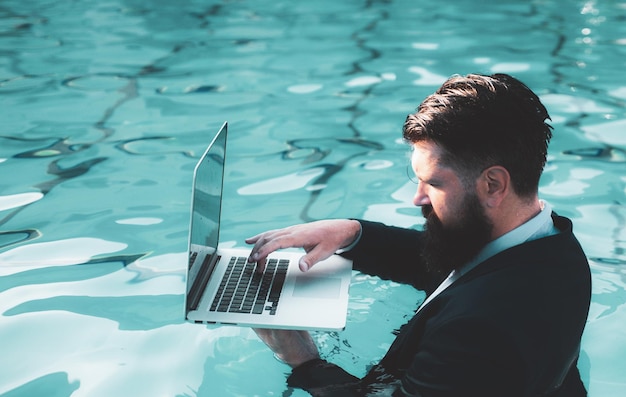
[254,329,319,368]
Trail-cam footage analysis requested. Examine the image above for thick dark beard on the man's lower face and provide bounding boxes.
[421,194,493,275]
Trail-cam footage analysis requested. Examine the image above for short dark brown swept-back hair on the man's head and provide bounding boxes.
[403,74,552,197]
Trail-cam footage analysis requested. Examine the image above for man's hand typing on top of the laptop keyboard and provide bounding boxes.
[246,219,361,272]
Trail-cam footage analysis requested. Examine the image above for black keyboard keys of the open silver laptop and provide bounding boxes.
[209,257,289,315]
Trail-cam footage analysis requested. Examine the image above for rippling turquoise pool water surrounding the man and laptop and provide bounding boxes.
[0,0,626,397]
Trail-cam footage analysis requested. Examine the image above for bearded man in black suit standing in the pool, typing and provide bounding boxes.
[247,74,591,397]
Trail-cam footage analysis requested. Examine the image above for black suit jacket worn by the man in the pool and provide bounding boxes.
[288,216,591,397]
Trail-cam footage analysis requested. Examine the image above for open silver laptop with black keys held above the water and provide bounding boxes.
[185,122,352,331]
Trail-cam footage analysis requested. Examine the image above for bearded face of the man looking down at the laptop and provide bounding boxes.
[411,141,493,274]
